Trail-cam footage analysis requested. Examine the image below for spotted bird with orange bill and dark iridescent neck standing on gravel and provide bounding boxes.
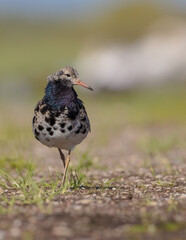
[32,66,93,186]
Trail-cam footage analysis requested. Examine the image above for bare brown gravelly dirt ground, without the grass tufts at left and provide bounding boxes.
[0,126,186,240]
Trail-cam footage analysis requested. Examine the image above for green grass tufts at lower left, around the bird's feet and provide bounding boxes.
[0,152,96,214]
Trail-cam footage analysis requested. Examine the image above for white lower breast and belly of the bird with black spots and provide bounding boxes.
[33,110,89,150]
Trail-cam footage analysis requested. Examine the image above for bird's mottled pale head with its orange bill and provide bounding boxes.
[47,66,93,91]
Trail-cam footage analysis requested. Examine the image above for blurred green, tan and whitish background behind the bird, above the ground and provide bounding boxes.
[0,0,186,159]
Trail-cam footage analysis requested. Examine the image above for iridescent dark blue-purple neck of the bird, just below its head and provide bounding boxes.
[44,82,77,110]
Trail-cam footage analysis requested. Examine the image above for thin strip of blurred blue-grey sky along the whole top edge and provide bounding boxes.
[0,0,186,17]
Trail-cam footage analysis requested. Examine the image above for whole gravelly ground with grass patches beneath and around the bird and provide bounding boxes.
[0,89,186,240]
